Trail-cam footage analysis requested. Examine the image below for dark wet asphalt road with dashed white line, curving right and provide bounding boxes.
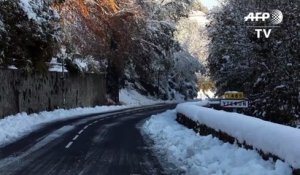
[0,105,174,175]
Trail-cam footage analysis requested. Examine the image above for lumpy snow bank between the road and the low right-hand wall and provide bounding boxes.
[142,110,292,175]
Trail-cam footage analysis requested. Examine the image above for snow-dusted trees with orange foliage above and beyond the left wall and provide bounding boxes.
[0,0,206,99]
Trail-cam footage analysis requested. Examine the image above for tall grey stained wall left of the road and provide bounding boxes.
[0,69,106,117]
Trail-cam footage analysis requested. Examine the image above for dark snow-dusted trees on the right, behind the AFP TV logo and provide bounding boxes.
[208,0,300,125]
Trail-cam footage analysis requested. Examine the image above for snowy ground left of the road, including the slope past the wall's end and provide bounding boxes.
[0,89,166,147]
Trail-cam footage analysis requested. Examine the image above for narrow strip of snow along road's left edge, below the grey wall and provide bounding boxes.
[0,106,132,146]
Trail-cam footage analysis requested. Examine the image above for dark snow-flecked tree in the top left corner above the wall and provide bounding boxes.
[0,0,59,71]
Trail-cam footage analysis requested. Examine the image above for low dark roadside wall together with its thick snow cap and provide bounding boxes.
[176,105,300,175]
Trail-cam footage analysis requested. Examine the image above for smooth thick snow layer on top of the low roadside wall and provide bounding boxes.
[176,104,300,169]
